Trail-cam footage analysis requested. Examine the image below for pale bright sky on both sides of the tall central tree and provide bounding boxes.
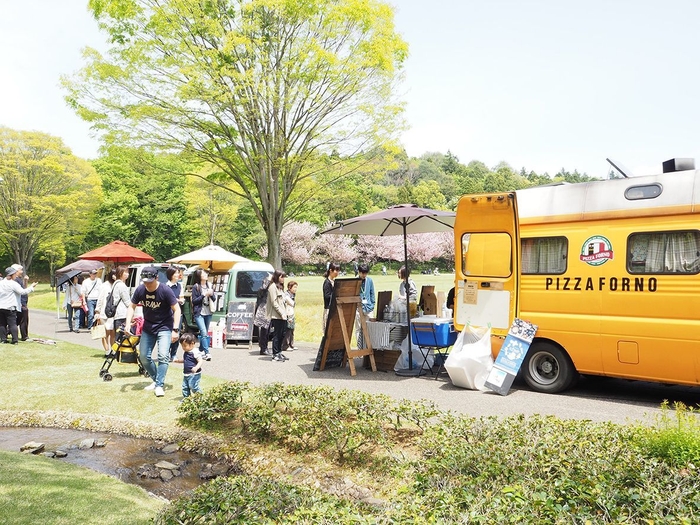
[0,0,700,177]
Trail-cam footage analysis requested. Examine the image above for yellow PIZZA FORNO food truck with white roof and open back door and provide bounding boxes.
[454,159,700,393]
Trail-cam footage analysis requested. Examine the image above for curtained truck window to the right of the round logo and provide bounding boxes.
[627,230,700,274]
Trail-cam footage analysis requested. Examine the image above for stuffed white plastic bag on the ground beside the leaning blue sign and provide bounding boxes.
[445,326,493,390]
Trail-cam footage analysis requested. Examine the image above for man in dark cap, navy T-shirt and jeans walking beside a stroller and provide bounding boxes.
[126,266,180,397]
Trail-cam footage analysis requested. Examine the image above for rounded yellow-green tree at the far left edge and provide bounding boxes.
[0,128,101,268]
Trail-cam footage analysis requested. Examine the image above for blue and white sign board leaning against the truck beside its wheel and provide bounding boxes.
[485,318,537,396]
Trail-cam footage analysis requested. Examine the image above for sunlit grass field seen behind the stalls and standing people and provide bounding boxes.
[29,273,454,342]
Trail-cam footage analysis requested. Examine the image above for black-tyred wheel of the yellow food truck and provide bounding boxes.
[523,341,578,394]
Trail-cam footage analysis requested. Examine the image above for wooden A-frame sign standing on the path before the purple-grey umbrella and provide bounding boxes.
[314,279,377,376]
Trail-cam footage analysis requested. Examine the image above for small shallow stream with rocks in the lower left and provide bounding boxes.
[0,427,225,500]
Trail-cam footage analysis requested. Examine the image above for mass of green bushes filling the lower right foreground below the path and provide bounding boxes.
[159,383,700,524]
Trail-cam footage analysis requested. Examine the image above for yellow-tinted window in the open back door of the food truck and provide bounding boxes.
[462,233,513,277]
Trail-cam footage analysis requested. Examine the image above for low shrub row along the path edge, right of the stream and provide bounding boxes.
[179,382,439,461]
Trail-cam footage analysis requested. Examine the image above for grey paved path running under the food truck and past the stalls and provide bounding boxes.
[30,310,700,423]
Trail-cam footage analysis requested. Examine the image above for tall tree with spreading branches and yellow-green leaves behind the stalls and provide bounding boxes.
[65,0,407,265]
